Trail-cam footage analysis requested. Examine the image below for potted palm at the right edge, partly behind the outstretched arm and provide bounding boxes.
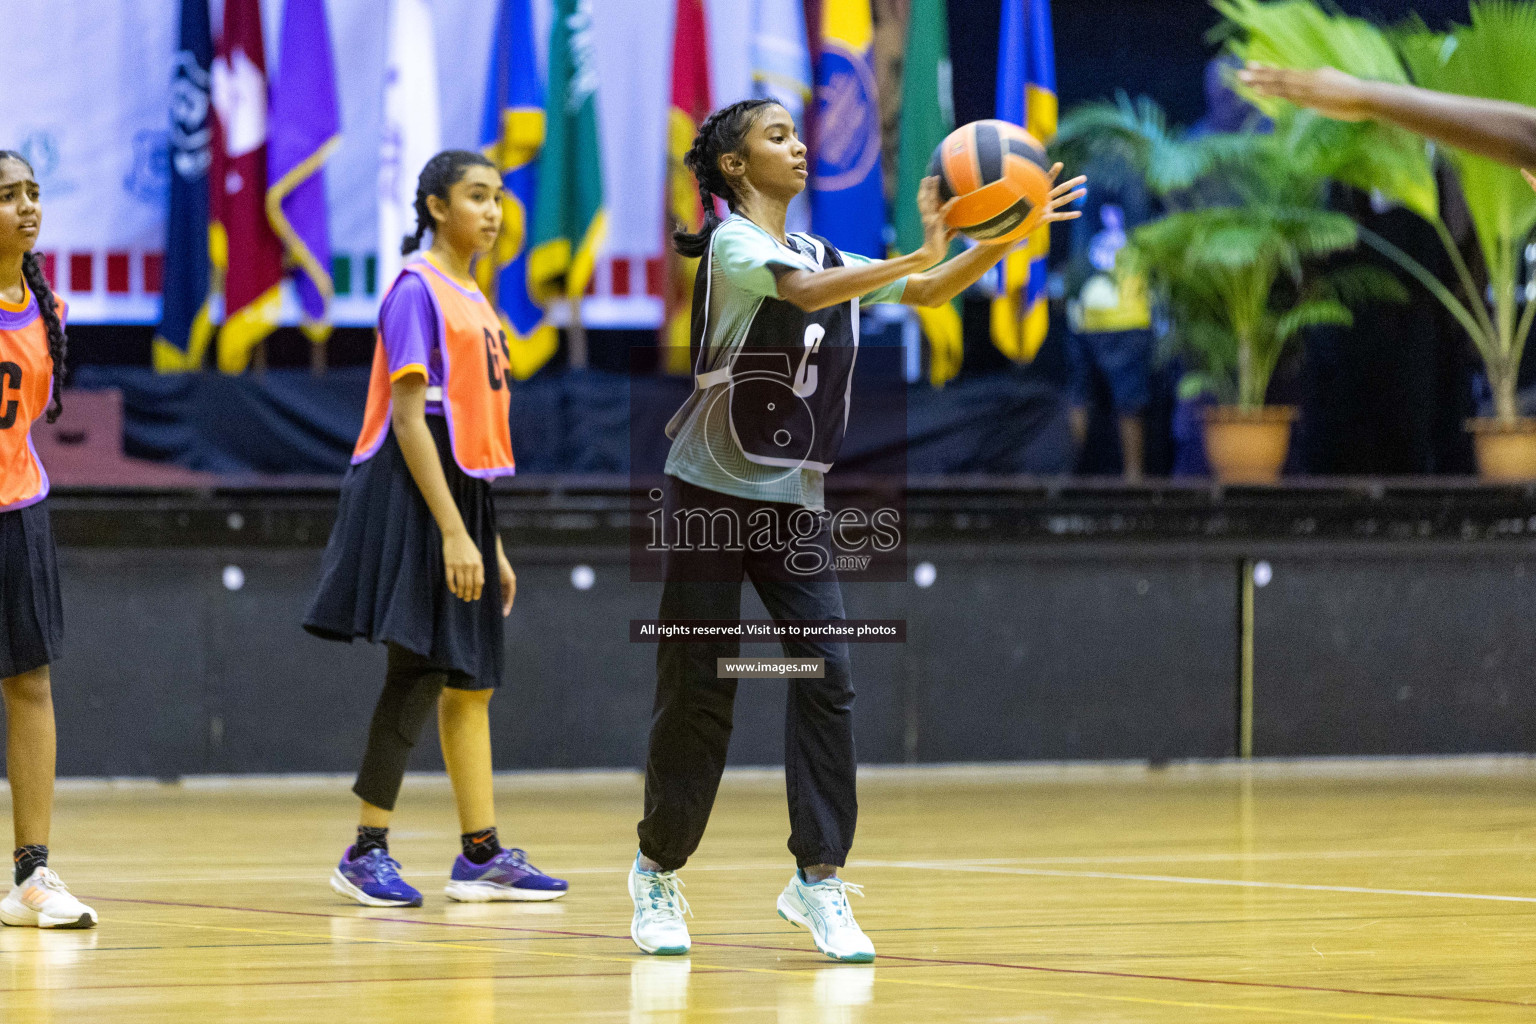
[1212,0,1536,479]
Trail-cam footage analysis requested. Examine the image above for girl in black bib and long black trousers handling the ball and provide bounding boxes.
[630,100,1083,963]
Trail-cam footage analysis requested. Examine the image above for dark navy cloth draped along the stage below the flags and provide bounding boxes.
[71,362,1072,474]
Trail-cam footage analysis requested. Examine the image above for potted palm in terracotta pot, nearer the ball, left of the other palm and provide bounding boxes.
[1055,95,1402,482]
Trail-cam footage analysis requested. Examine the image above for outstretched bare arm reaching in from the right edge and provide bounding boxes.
[1238,64,1536,178]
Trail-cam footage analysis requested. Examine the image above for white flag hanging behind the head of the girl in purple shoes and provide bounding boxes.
[378,0,442,294]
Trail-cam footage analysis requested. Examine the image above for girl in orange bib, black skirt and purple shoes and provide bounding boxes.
[304,150,567,906]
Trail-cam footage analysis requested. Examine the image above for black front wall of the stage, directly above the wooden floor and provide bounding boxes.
[49,474,1536,777]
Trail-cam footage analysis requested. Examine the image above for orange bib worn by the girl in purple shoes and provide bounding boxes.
[352,259,516,481]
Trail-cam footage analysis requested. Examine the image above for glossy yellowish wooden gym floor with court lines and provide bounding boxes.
[0,758,1536,1024]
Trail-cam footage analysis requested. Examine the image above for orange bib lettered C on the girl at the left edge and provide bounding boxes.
[0,290,65,511]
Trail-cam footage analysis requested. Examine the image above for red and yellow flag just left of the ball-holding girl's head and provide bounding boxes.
[662,0,714,375]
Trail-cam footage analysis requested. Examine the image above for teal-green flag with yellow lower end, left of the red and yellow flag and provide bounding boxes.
[528,0,608,304]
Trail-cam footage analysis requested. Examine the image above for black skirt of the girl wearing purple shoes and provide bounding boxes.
[304,416,504,689]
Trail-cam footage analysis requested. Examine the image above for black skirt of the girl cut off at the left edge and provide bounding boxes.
[0,500,65,679]
